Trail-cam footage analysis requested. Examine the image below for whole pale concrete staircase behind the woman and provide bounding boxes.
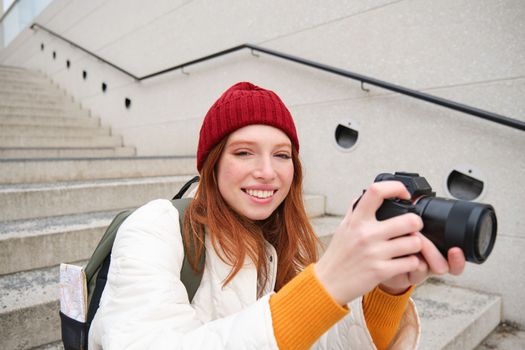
[0,67,501,350]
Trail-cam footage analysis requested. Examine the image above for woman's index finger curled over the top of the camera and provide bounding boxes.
[353,181,410,219]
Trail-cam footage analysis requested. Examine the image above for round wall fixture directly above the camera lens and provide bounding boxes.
[444,165,486,201]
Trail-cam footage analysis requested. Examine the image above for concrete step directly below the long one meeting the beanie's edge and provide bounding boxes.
[0,176,190,221]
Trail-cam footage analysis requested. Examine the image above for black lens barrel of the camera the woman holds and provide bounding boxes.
[415,196,497,264]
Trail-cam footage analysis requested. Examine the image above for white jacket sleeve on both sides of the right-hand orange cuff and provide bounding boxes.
[313,297,420,350]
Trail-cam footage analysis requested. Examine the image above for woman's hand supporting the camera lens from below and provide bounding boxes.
[379,232,465,295]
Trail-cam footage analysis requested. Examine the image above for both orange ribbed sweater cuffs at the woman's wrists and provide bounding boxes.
[270,264,413,350]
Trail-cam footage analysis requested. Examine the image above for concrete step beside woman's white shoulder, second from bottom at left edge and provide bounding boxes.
[0,191,324,275]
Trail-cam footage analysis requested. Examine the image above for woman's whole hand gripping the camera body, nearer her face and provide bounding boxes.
[315,181,423,305]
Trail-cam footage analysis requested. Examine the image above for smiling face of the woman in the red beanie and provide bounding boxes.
[217,125,294,220]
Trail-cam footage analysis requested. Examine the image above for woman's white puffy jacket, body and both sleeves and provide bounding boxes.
[89,199,419,350]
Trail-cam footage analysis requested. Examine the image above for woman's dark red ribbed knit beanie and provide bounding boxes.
[197,82,299,172]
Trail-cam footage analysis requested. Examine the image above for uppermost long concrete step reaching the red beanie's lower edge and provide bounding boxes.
[0,156,197,184]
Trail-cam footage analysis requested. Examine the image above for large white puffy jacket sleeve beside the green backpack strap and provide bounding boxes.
[89,200,277,350]
